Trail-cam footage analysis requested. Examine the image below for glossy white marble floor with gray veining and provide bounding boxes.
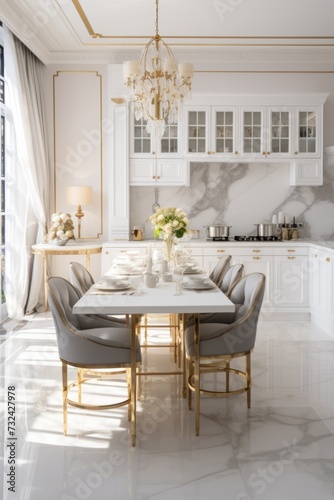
[0,314,334,500]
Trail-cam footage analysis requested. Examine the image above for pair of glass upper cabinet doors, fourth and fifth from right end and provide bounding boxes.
[183,106,238,159]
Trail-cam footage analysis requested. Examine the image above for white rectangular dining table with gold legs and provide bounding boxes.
[73,281,235,446]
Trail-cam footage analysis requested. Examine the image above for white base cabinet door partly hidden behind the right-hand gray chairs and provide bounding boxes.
[233,255,273,307]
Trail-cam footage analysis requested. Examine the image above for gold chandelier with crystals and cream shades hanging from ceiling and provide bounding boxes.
[123,0,194,137]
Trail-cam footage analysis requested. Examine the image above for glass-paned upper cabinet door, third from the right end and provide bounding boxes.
[241,107,267,158]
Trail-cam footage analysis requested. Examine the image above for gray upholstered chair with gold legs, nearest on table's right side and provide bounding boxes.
[185,273,265,435]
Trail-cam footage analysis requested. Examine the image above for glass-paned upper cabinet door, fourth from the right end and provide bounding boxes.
[210,106,238,157]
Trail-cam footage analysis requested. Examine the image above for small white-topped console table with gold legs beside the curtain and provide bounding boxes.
[31,243,102,310]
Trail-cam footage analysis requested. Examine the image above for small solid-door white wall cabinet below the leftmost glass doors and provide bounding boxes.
[129,159,189,186]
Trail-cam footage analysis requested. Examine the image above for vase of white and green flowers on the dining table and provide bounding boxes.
[150,207,189,262]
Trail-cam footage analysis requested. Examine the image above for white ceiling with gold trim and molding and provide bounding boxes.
[0,0,334,71]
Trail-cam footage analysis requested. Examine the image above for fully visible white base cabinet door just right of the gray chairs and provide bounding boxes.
[273,255,308,308]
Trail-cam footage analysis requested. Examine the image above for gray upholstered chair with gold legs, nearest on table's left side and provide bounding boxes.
[48,277,141,445]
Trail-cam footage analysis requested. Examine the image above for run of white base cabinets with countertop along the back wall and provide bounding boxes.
[102,239,334,337]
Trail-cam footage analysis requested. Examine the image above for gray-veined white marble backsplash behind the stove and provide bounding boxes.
[130,162,334,240]
